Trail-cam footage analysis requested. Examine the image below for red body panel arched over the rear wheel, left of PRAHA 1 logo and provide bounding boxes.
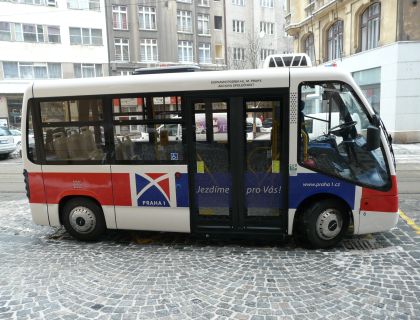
[43,172,113,206]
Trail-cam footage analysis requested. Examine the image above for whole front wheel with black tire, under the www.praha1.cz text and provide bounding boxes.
[301,199,350,249]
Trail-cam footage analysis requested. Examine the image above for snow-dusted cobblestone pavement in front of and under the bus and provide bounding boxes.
[0,194,420,320]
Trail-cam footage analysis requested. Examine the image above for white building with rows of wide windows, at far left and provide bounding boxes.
[0,0,108,128]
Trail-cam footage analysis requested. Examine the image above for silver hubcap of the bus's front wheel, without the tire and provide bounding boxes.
[316,209,343,240]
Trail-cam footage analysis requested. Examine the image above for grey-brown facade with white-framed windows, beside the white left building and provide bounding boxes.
[106,0,226,75]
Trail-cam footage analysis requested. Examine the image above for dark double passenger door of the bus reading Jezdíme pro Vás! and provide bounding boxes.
[189,94,287,235]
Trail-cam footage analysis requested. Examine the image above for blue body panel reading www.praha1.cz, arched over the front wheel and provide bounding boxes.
[289,173,356,209]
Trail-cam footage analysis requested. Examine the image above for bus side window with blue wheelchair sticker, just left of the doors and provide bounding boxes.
[113,96,185,163]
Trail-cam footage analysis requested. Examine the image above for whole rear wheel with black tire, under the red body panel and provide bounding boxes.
[62,198,106,241]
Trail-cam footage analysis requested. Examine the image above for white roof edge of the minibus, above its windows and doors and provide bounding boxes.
[27,67,352,98]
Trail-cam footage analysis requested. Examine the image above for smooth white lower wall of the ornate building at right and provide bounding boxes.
[337,42,420,142]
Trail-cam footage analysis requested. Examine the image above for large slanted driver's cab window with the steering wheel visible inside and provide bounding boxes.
[299,81,389,188]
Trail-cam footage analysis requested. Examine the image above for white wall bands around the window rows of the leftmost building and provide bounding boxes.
[0,0,108,63]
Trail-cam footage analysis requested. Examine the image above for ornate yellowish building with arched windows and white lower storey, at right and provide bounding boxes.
[286,0,420,142]
